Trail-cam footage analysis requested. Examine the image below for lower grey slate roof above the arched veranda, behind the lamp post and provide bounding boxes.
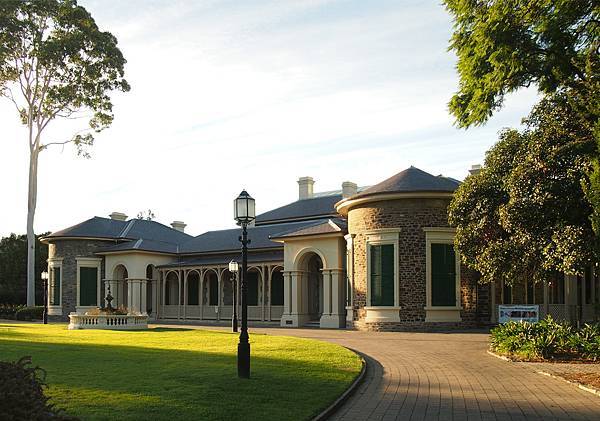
[179,219,336,254]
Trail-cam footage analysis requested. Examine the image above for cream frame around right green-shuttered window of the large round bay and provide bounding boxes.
[423,227,462,322]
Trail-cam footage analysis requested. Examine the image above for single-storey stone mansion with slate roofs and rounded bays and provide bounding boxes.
[42,167,600,330]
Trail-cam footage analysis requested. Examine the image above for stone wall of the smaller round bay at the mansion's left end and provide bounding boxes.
[48,240,112,321]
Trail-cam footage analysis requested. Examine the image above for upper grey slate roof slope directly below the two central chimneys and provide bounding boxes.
[256,194,342,225]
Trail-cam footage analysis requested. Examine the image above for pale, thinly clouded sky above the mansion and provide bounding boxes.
[0,0,537,236]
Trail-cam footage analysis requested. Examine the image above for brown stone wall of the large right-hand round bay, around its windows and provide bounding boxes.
[348,199,489,330]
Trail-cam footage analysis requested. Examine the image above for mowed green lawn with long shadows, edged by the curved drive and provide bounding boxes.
[0,323,361,420]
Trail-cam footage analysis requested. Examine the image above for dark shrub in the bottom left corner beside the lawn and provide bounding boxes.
[0,357,77,421]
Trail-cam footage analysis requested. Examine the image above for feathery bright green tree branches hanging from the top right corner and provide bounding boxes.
[444,0,600,127]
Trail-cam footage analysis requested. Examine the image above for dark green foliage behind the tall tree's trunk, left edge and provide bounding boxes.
[0,233,48,304]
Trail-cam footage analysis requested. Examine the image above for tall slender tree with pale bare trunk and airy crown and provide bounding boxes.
[0,0,129,305]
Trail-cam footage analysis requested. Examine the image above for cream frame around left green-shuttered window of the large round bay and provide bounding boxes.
[365,228,401,322]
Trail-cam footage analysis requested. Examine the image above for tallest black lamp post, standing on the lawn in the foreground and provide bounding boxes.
[233,190,256,379]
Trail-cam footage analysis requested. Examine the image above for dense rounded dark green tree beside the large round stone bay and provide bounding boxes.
[450,95,596,285]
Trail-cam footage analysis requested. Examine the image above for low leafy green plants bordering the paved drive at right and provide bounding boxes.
[490,316,600,361]
